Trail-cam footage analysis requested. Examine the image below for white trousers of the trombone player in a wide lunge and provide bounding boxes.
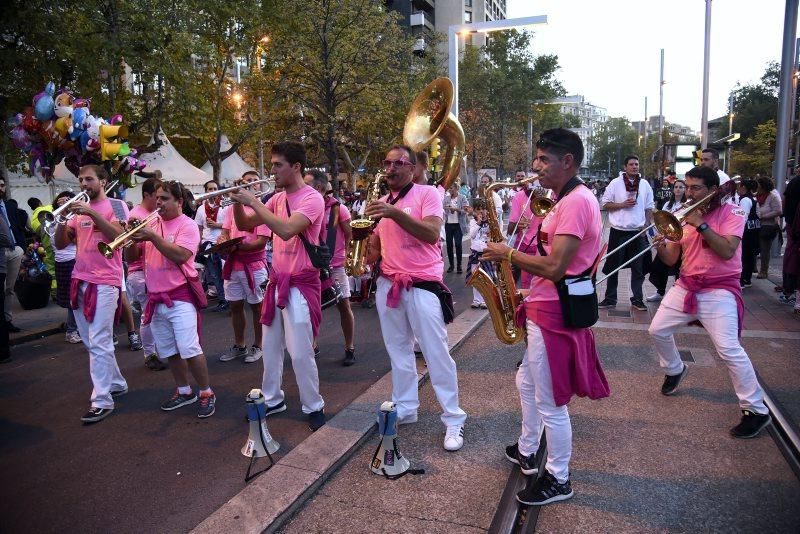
[649,285,767,414]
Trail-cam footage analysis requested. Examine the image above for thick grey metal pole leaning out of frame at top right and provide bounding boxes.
[772,0,798,193]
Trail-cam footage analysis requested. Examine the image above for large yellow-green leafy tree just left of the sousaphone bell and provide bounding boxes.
[271,0,417,191]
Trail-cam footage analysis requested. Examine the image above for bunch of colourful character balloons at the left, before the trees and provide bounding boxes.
[8,82,146,187]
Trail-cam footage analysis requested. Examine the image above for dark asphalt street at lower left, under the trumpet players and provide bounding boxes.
[0,274,472,532]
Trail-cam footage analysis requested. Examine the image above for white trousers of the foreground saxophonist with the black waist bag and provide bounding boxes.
[517,320,572,484]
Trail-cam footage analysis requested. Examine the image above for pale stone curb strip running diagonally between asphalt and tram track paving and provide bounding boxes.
[191,309,489,534]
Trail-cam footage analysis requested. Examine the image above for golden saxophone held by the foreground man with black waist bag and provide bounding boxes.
[467,176,537,345]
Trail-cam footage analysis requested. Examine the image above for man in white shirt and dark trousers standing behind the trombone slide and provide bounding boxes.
[598,156,655,311]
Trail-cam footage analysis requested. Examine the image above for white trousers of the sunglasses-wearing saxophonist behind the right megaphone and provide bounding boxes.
[375,276,467,426]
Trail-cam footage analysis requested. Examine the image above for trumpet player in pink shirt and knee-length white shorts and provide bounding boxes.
[125,182,217,418]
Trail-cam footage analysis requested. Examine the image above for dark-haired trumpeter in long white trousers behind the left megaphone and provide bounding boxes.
[231,141,325,430]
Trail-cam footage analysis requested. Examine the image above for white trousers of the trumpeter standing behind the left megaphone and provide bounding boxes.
[261,287,325,414]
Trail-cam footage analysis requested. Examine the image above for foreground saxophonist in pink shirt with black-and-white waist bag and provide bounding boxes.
[481,128,609,505]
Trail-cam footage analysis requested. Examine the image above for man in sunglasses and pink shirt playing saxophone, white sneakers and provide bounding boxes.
[366,145,467,451]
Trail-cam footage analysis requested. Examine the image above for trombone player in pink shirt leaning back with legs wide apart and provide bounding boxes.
[649,166,771,438]
